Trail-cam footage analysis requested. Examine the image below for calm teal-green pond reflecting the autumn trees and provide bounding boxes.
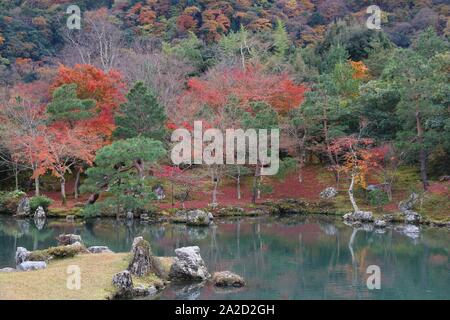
[0,216,450,299]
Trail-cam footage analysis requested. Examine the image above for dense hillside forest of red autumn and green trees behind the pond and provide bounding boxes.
[0,0,450,220]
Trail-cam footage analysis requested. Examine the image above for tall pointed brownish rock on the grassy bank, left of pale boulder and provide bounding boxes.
[128,237,164,277]
